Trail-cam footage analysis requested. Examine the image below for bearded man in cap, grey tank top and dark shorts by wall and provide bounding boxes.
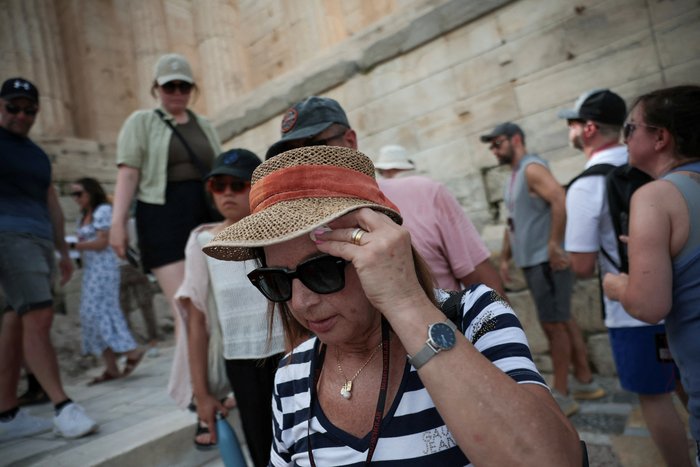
[481,122,605,416]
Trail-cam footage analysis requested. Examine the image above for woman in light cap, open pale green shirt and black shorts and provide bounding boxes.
[110,54,221,340]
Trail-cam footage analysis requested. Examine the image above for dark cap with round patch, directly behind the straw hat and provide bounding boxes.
[265,96,350,160]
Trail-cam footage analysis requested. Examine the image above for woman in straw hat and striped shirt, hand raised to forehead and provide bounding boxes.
[204,146,582,467]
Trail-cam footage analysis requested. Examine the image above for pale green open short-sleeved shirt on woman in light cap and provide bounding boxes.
[117,107,223,204]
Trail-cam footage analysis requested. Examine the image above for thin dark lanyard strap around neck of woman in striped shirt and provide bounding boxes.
[306,317,389,467]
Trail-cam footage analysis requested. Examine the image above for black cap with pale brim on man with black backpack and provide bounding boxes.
[557,89,627,126]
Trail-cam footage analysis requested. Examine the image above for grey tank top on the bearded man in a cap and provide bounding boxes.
[503,154,552,268]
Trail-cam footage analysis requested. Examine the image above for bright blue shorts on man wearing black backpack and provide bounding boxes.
[608,324,680,394]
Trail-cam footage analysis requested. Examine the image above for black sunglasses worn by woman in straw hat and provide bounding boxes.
[248,254,350,302]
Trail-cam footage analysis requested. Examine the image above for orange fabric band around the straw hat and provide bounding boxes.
[250,165,399,214]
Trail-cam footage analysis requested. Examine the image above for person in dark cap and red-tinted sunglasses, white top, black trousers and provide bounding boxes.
[168,149,284,467]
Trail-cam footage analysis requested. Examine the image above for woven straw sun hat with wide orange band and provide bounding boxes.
[202,146,403,261]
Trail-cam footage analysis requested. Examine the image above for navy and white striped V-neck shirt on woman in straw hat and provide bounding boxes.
[270,284,546,467]
